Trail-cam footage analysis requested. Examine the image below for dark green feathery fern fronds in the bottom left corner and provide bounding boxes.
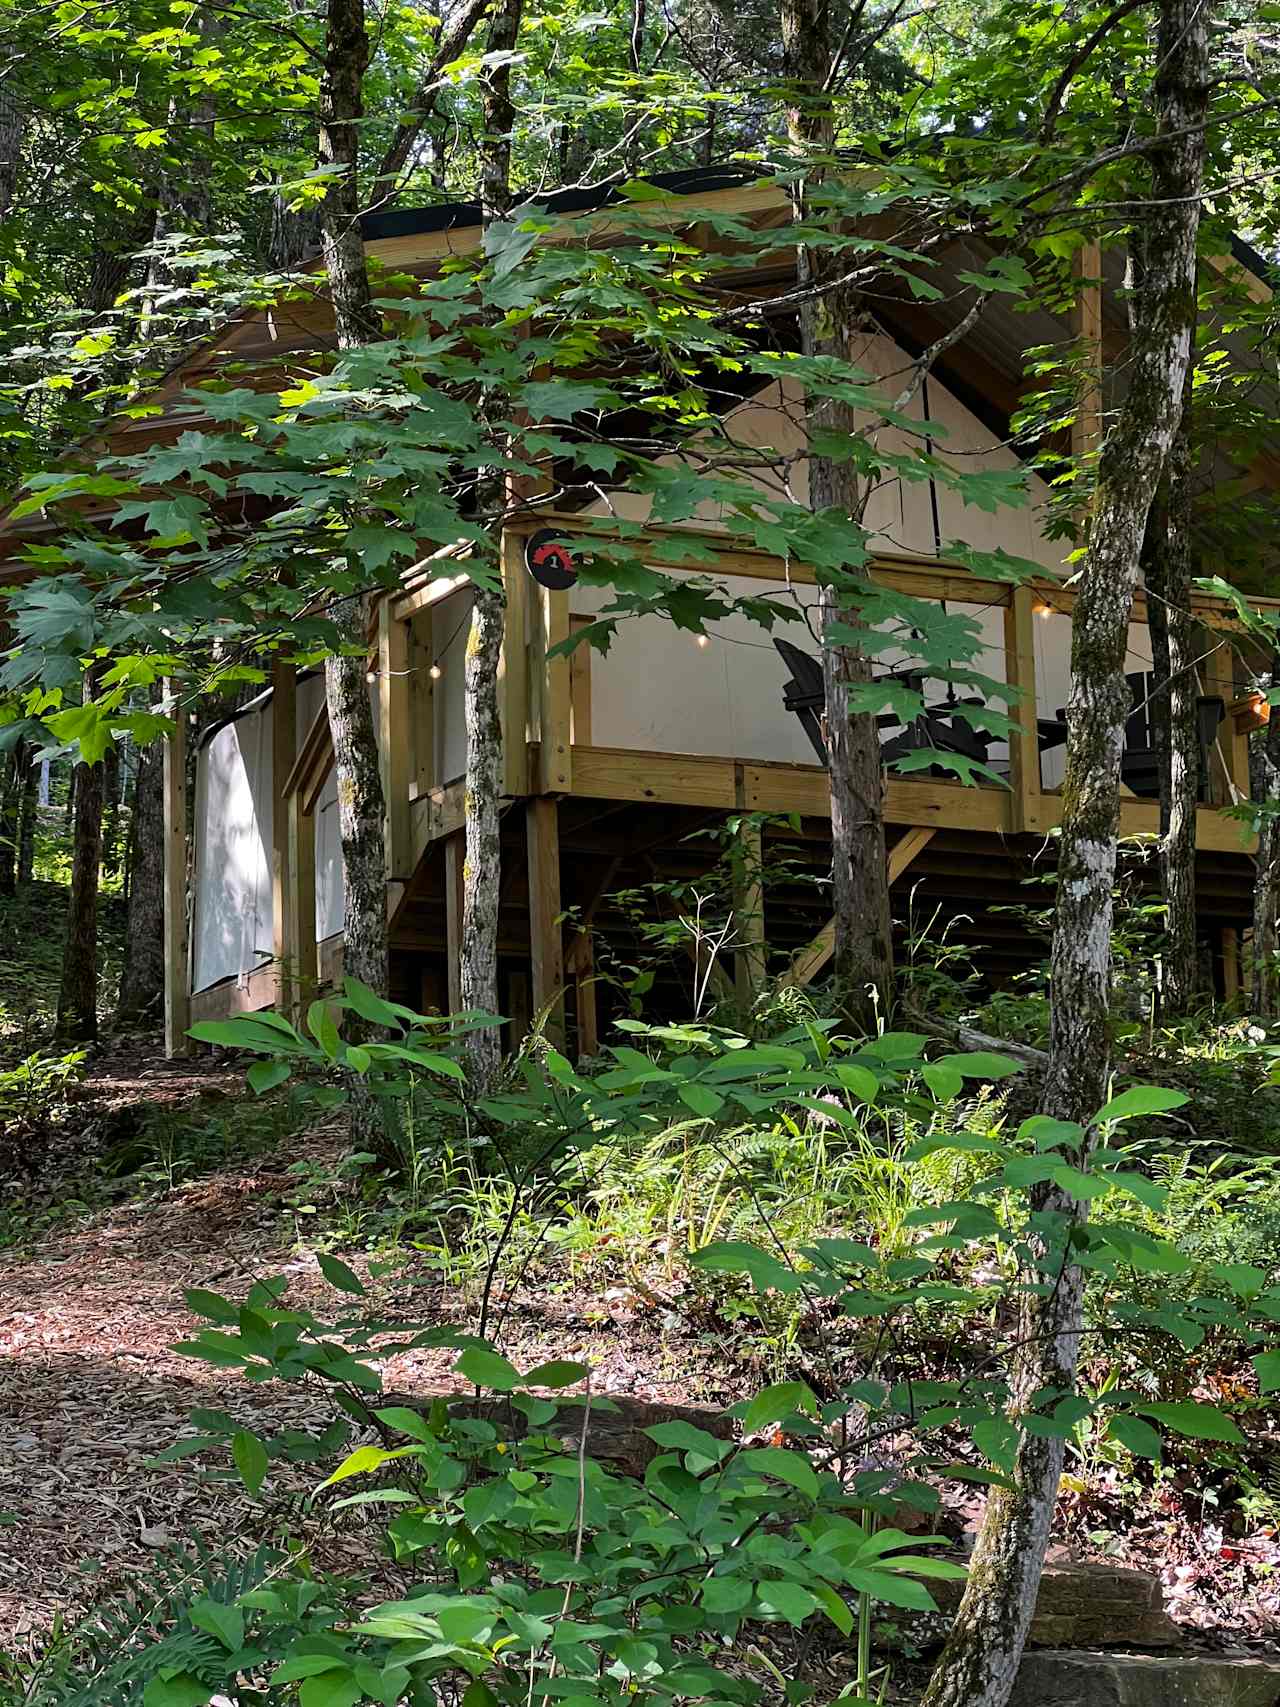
[19,1536,283,1707]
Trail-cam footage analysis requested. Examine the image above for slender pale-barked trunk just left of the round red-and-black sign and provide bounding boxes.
[459,0,522,1089]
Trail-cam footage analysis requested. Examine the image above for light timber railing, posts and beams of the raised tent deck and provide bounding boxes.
[167,517,1276,1046]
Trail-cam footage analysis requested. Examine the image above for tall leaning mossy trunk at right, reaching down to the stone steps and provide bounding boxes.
[922,0,1210,1707]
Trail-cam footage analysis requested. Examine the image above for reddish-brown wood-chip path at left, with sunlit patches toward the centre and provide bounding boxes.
[0,1062,734,1646]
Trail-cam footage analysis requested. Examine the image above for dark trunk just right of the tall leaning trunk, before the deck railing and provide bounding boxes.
[1142,364,1200,1019]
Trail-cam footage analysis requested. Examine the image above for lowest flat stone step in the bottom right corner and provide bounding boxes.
[1009,1649,1280,1707]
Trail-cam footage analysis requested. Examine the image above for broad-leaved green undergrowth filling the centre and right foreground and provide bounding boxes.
[17,983,1280,1707]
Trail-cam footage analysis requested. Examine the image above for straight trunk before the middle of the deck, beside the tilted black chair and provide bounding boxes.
[782,0,893,1031]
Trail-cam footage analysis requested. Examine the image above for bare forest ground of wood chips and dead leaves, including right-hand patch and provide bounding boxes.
[0,1040,1280,1647]
